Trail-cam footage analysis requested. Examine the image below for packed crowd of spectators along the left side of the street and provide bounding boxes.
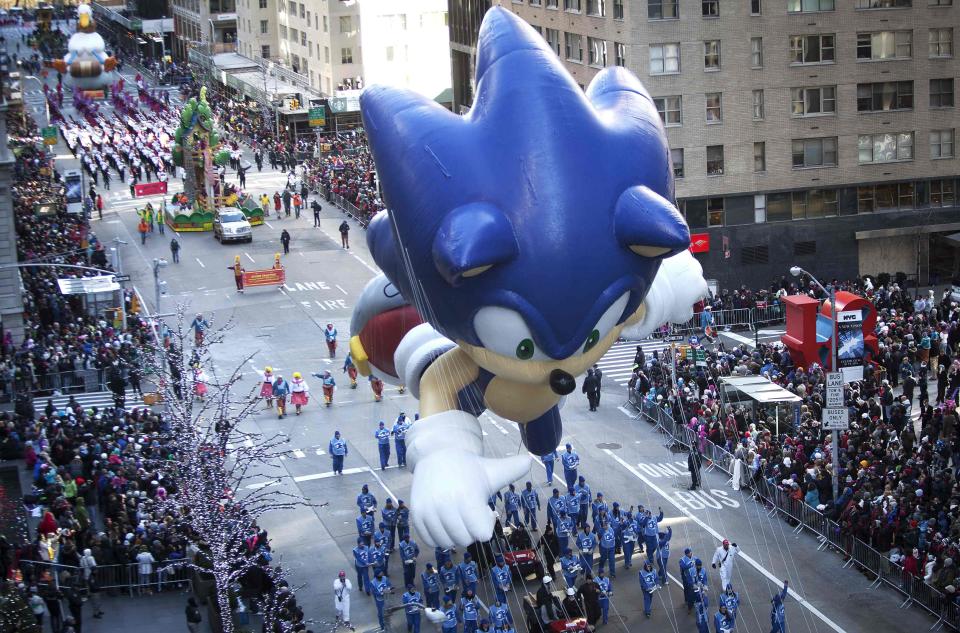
[0,106,303,631]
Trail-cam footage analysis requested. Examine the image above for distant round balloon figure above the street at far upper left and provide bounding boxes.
[46,4,117,91]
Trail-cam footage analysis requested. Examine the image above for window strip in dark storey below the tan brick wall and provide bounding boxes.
[678,178,957,229]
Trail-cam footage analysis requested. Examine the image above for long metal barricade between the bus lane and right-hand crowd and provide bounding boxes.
[625,389,960,631]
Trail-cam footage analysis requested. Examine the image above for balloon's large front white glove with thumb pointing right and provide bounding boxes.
[406,411,530,547]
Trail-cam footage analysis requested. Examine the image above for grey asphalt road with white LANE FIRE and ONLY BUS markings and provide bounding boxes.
[8,22,933,633]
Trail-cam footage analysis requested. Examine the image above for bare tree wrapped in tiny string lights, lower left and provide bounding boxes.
[148,306,311,633]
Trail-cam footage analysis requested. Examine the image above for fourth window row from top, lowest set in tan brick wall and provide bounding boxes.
[670,128,956,179]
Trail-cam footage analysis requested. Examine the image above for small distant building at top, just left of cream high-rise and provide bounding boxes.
[170,0,236,61]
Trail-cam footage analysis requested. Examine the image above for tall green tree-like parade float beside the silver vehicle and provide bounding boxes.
[164,87,233,231]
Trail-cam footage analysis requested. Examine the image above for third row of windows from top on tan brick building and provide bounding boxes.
[653,77,955,127]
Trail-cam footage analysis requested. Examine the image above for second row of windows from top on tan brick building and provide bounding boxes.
[644,27,953,75]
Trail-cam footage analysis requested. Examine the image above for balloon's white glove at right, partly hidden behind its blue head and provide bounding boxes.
[622,251,708,339]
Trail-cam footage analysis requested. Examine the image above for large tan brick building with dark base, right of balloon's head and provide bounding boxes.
[449,0,960,286]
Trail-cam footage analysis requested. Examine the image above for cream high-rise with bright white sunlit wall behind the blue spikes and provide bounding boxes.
[237,0,450,97]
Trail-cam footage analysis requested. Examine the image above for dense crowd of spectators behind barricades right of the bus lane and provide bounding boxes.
[631,276,960,596]
